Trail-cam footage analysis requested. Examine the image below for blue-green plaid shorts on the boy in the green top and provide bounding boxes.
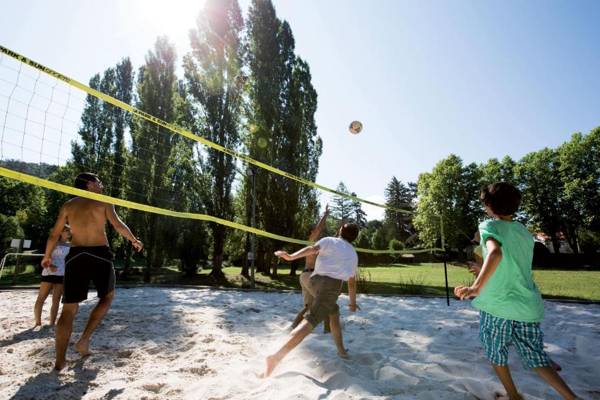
[479,311,551,368]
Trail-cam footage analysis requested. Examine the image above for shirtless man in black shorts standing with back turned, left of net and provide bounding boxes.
[42,172,143,371]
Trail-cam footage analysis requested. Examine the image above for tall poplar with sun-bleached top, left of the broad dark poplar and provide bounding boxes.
[183,0,244,277]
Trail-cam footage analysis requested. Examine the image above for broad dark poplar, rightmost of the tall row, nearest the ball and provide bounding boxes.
[244,0,322,274]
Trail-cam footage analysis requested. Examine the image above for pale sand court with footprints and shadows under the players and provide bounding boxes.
[0,288,600,400]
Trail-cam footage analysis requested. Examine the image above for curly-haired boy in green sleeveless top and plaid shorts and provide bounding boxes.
[454,182,577,400]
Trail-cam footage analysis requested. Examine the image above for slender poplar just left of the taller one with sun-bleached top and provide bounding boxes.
[127,37,178,281]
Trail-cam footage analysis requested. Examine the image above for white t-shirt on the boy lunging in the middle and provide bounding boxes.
[311,237,358,281]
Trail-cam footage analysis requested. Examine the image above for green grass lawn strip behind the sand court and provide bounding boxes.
[0,263,600,301]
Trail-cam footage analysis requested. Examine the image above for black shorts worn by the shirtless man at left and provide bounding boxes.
[62,246,115,304]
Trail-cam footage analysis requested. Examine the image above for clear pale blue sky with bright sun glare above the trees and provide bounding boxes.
[0,0,600,218]
